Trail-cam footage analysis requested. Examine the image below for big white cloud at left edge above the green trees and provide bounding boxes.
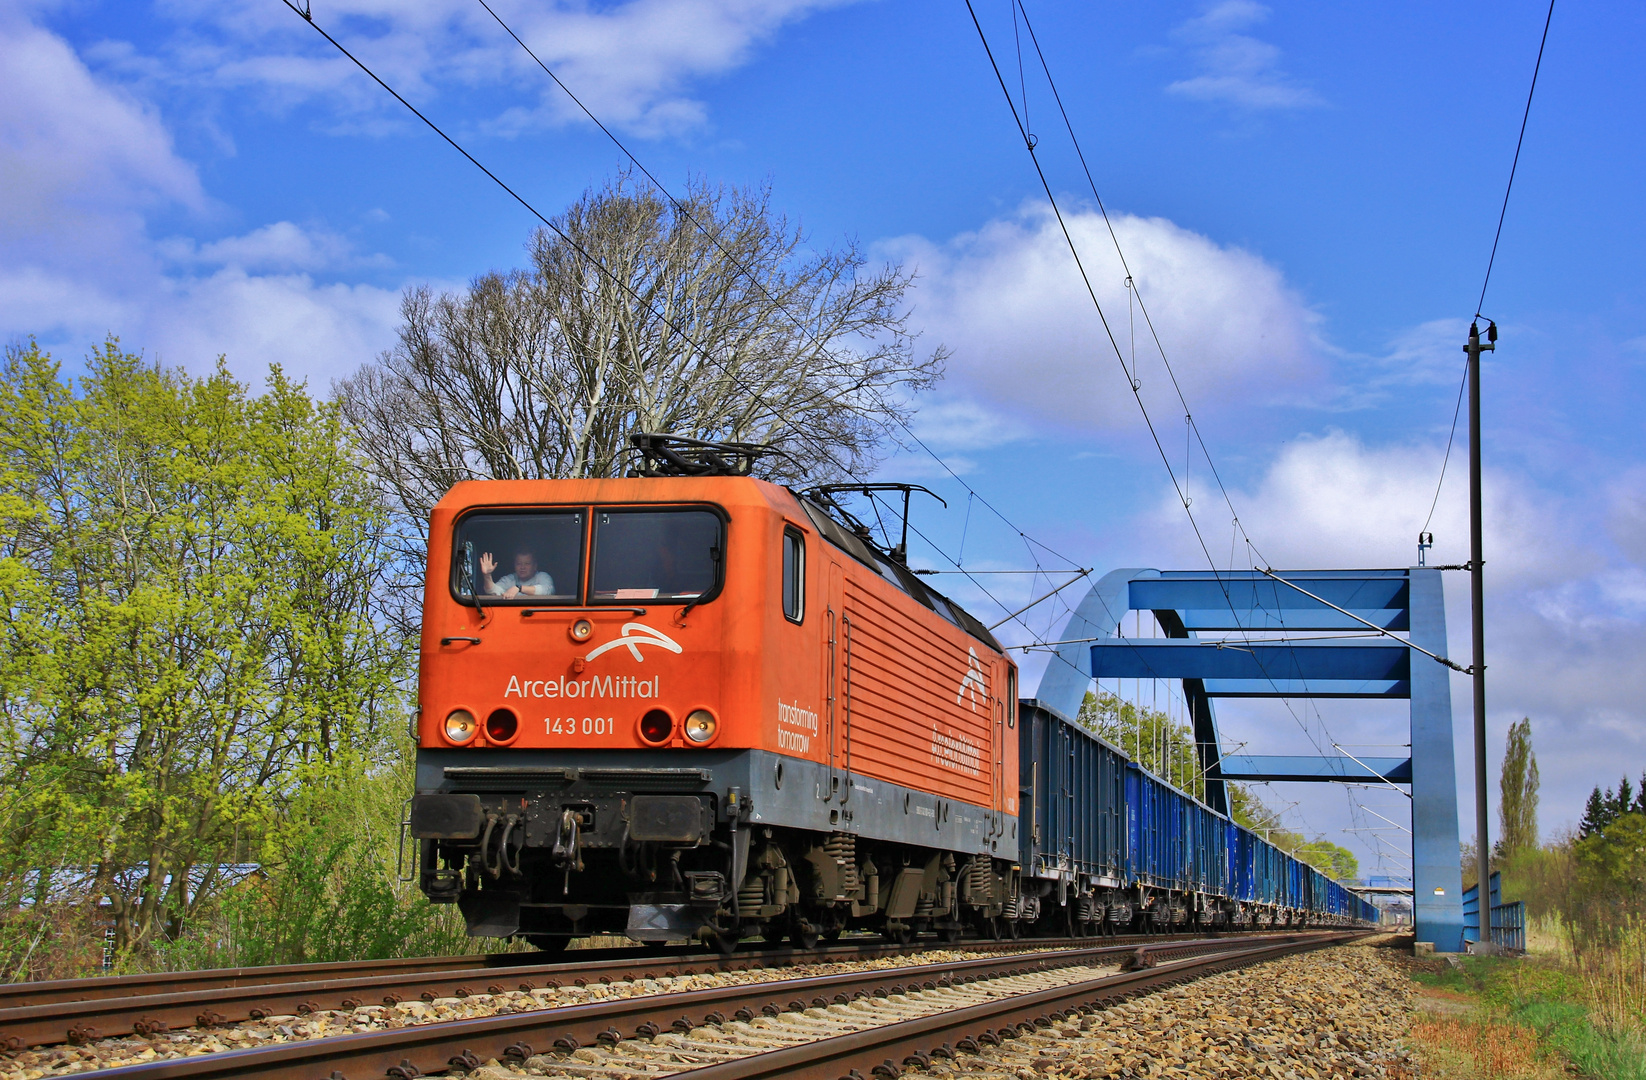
[0,8,398,385]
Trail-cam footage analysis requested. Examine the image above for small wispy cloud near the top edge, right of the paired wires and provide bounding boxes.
[1165,0,1325,110]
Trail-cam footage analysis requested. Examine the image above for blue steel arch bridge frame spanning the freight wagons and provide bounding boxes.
[1035,566,1463,952]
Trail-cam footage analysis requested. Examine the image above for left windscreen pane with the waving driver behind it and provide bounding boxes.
[451,510,583,604]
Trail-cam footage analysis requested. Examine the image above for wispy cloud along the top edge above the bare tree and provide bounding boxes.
[146,0,854,133]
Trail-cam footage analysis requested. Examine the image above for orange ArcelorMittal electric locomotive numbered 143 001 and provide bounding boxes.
[412,444,1019,948]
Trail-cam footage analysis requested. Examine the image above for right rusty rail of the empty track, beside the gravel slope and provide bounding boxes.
[670,930,1369,1080]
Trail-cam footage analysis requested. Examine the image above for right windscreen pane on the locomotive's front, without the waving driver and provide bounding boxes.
[589,509,724,604]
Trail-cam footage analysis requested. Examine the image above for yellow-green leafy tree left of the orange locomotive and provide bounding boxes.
[0,341,407,950]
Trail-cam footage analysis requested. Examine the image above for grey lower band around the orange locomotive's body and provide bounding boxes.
[416,749,1019,861]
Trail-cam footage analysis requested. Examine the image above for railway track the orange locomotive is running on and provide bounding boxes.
[0,935,1303,1050]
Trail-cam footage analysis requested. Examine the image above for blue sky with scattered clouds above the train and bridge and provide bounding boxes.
[0,0,1646,871]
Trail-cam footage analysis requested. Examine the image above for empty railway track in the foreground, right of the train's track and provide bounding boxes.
[54,932,1363,1080]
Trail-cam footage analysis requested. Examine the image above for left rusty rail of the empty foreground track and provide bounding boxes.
[80,932,1343,1080]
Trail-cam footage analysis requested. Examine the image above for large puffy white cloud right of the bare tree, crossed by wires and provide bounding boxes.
[879,203,1320,430]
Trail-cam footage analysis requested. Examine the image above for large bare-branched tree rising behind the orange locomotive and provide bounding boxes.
[339,173,945,527]
